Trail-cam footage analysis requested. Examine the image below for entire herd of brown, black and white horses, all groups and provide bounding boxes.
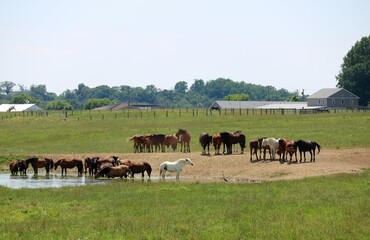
[9,129,321,179]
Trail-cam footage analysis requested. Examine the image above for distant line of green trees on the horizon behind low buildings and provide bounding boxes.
[0,78,301,110]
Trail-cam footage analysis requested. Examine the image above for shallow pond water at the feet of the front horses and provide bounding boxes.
[0,173,220,189]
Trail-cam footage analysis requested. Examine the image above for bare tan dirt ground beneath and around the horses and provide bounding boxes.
[47,148,370,182]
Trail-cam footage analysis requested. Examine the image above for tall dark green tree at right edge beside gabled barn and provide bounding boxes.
[336,36,370,105]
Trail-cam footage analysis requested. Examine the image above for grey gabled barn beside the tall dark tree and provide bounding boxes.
[307,88,360,109]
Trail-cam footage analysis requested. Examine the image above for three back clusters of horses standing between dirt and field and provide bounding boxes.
[129,129,321,162]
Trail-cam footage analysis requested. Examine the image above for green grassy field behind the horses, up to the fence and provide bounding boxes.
[0,110,370,156]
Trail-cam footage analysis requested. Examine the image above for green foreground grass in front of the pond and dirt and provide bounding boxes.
[0,170,370,239]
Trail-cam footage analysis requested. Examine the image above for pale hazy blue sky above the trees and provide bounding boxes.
[0,0,370,94]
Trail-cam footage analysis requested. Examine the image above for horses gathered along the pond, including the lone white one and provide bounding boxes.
[9,156,193,179]
